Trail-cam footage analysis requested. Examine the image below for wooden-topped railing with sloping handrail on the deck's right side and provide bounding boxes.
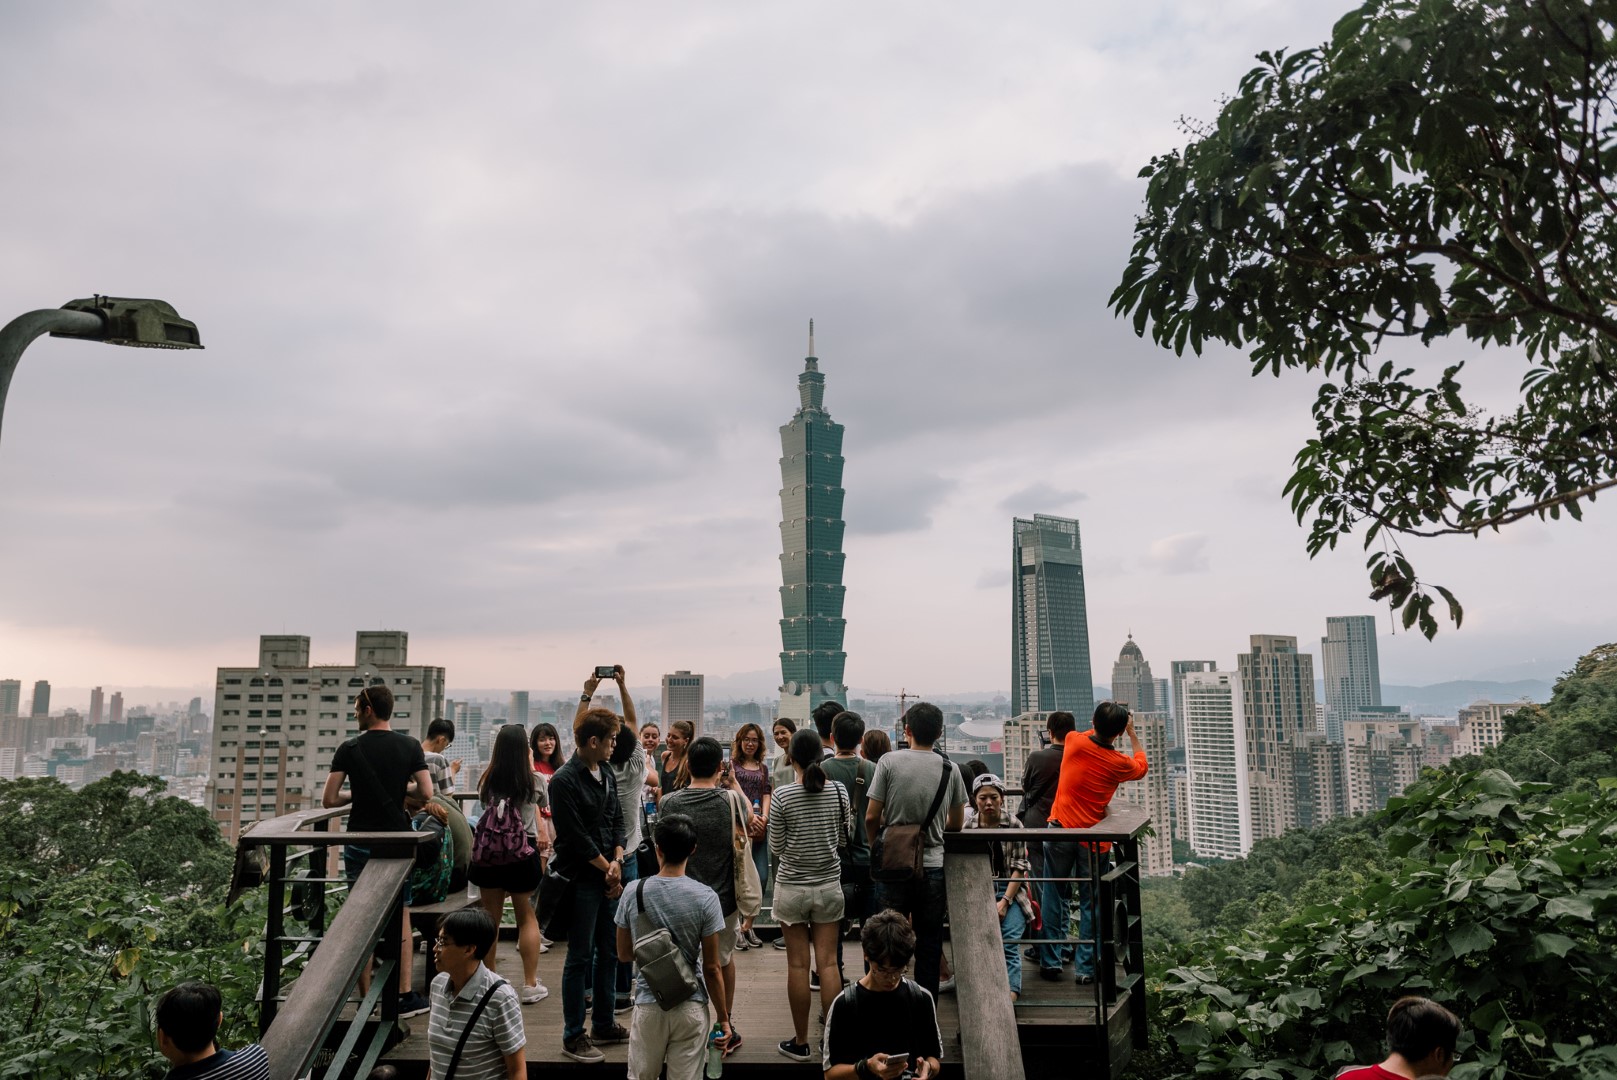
[943,804,1151,1080]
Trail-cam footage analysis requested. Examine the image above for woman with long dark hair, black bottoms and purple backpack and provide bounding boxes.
[466,724,550,1006]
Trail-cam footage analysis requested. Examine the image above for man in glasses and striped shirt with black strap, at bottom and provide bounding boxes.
[427,907,527,1080]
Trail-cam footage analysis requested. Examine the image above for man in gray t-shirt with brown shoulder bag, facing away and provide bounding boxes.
[865,702,965,998]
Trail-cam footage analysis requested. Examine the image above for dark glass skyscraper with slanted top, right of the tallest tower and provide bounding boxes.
[1011,514,1095,723]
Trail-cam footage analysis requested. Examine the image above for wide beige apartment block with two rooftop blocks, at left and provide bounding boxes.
[211,631,449,842]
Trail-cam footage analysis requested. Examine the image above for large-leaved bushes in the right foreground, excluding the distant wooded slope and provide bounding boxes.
[1158,770,1617,1080]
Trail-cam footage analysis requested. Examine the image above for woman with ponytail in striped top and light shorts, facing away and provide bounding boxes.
[768,728,854,1061]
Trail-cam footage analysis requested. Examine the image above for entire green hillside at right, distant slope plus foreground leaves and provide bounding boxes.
[1137,645,1617,1080]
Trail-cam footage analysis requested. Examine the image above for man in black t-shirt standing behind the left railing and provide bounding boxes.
[320,686,432,1015]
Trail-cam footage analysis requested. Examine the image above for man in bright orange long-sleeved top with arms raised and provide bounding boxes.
[1038,702,1148,985]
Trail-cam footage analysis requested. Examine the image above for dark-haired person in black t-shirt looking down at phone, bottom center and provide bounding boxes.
[825,910,943,1080]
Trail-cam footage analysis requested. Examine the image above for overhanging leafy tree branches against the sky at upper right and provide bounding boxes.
[1111,0,1617,637]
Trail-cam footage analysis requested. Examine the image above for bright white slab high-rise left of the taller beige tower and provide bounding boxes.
[1182,671,1253,859]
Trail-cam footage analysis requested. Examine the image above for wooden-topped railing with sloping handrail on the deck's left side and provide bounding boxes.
[231,807,432,1080]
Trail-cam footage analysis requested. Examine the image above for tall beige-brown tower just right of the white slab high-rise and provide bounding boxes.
[1235,634,1315,841]
